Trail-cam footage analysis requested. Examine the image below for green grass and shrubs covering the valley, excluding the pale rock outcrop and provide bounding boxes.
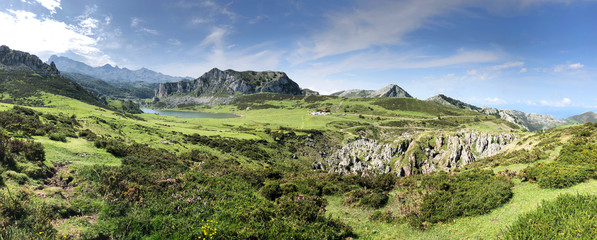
[0,93,597,239]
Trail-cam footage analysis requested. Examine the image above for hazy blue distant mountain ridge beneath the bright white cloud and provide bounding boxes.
[48,55,183,83]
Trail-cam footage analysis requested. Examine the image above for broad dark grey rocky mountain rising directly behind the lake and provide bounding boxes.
[156,68,303,99]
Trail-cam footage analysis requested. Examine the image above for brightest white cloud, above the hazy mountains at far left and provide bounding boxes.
[0,10,113,65]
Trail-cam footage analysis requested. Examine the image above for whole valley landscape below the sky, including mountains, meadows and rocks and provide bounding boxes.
[0,46,597,239]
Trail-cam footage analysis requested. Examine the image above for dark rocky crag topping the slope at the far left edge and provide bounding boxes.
[0,45,60,76]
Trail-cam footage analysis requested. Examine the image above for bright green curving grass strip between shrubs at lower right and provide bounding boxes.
[327,180,597,239]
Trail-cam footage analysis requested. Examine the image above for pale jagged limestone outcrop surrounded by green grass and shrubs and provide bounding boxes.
[314,132,519,176]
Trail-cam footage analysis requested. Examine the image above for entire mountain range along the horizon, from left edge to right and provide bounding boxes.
[0,46,597,131]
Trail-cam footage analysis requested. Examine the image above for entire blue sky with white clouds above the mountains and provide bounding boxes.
[0,0,597,118]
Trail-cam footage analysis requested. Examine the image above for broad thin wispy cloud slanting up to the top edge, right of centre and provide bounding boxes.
[290,0,468,64]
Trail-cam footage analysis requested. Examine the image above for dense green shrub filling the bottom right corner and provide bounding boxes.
[502,194,597,239]
